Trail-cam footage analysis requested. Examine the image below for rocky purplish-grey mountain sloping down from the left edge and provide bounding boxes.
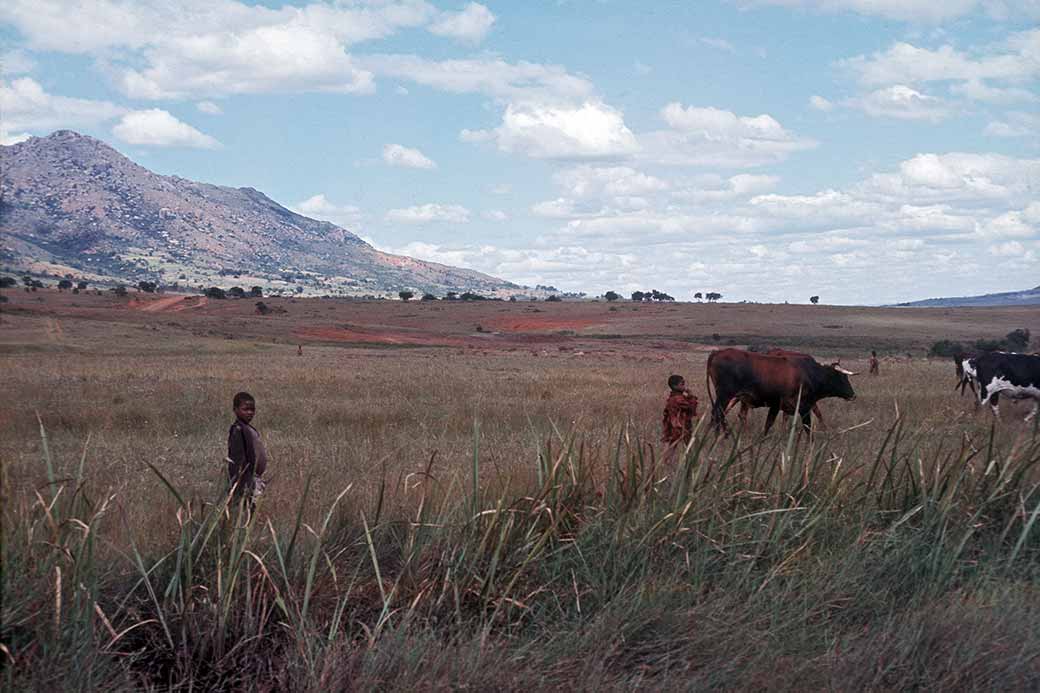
[0,130,520,296]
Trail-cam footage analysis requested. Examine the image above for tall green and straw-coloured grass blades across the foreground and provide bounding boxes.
[0,409,1040,690]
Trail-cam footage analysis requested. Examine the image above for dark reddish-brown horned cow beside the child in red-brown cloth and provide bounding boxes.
[706,349,856,432]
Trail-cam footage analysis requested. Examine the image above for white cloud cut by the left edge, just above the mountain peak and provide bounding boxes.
[0,77,126,136]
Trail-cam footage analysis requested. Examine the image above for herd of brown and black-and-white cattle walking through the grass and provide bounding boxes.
[706,349,1040,432]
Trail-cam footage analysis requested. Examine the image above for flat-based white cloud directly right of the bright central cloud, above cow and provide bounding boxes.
[640,103,816,168]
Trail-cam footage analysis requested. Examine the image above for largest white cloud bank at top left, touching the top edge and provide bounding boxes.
[0,0,443,99]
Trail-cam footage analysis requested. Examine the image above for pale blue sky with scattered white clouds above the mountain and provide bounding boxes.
[0,0,1040,305]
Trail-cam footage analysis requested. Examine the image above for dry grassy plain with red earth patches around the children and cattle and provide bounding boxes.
[0,291,1040,691]
